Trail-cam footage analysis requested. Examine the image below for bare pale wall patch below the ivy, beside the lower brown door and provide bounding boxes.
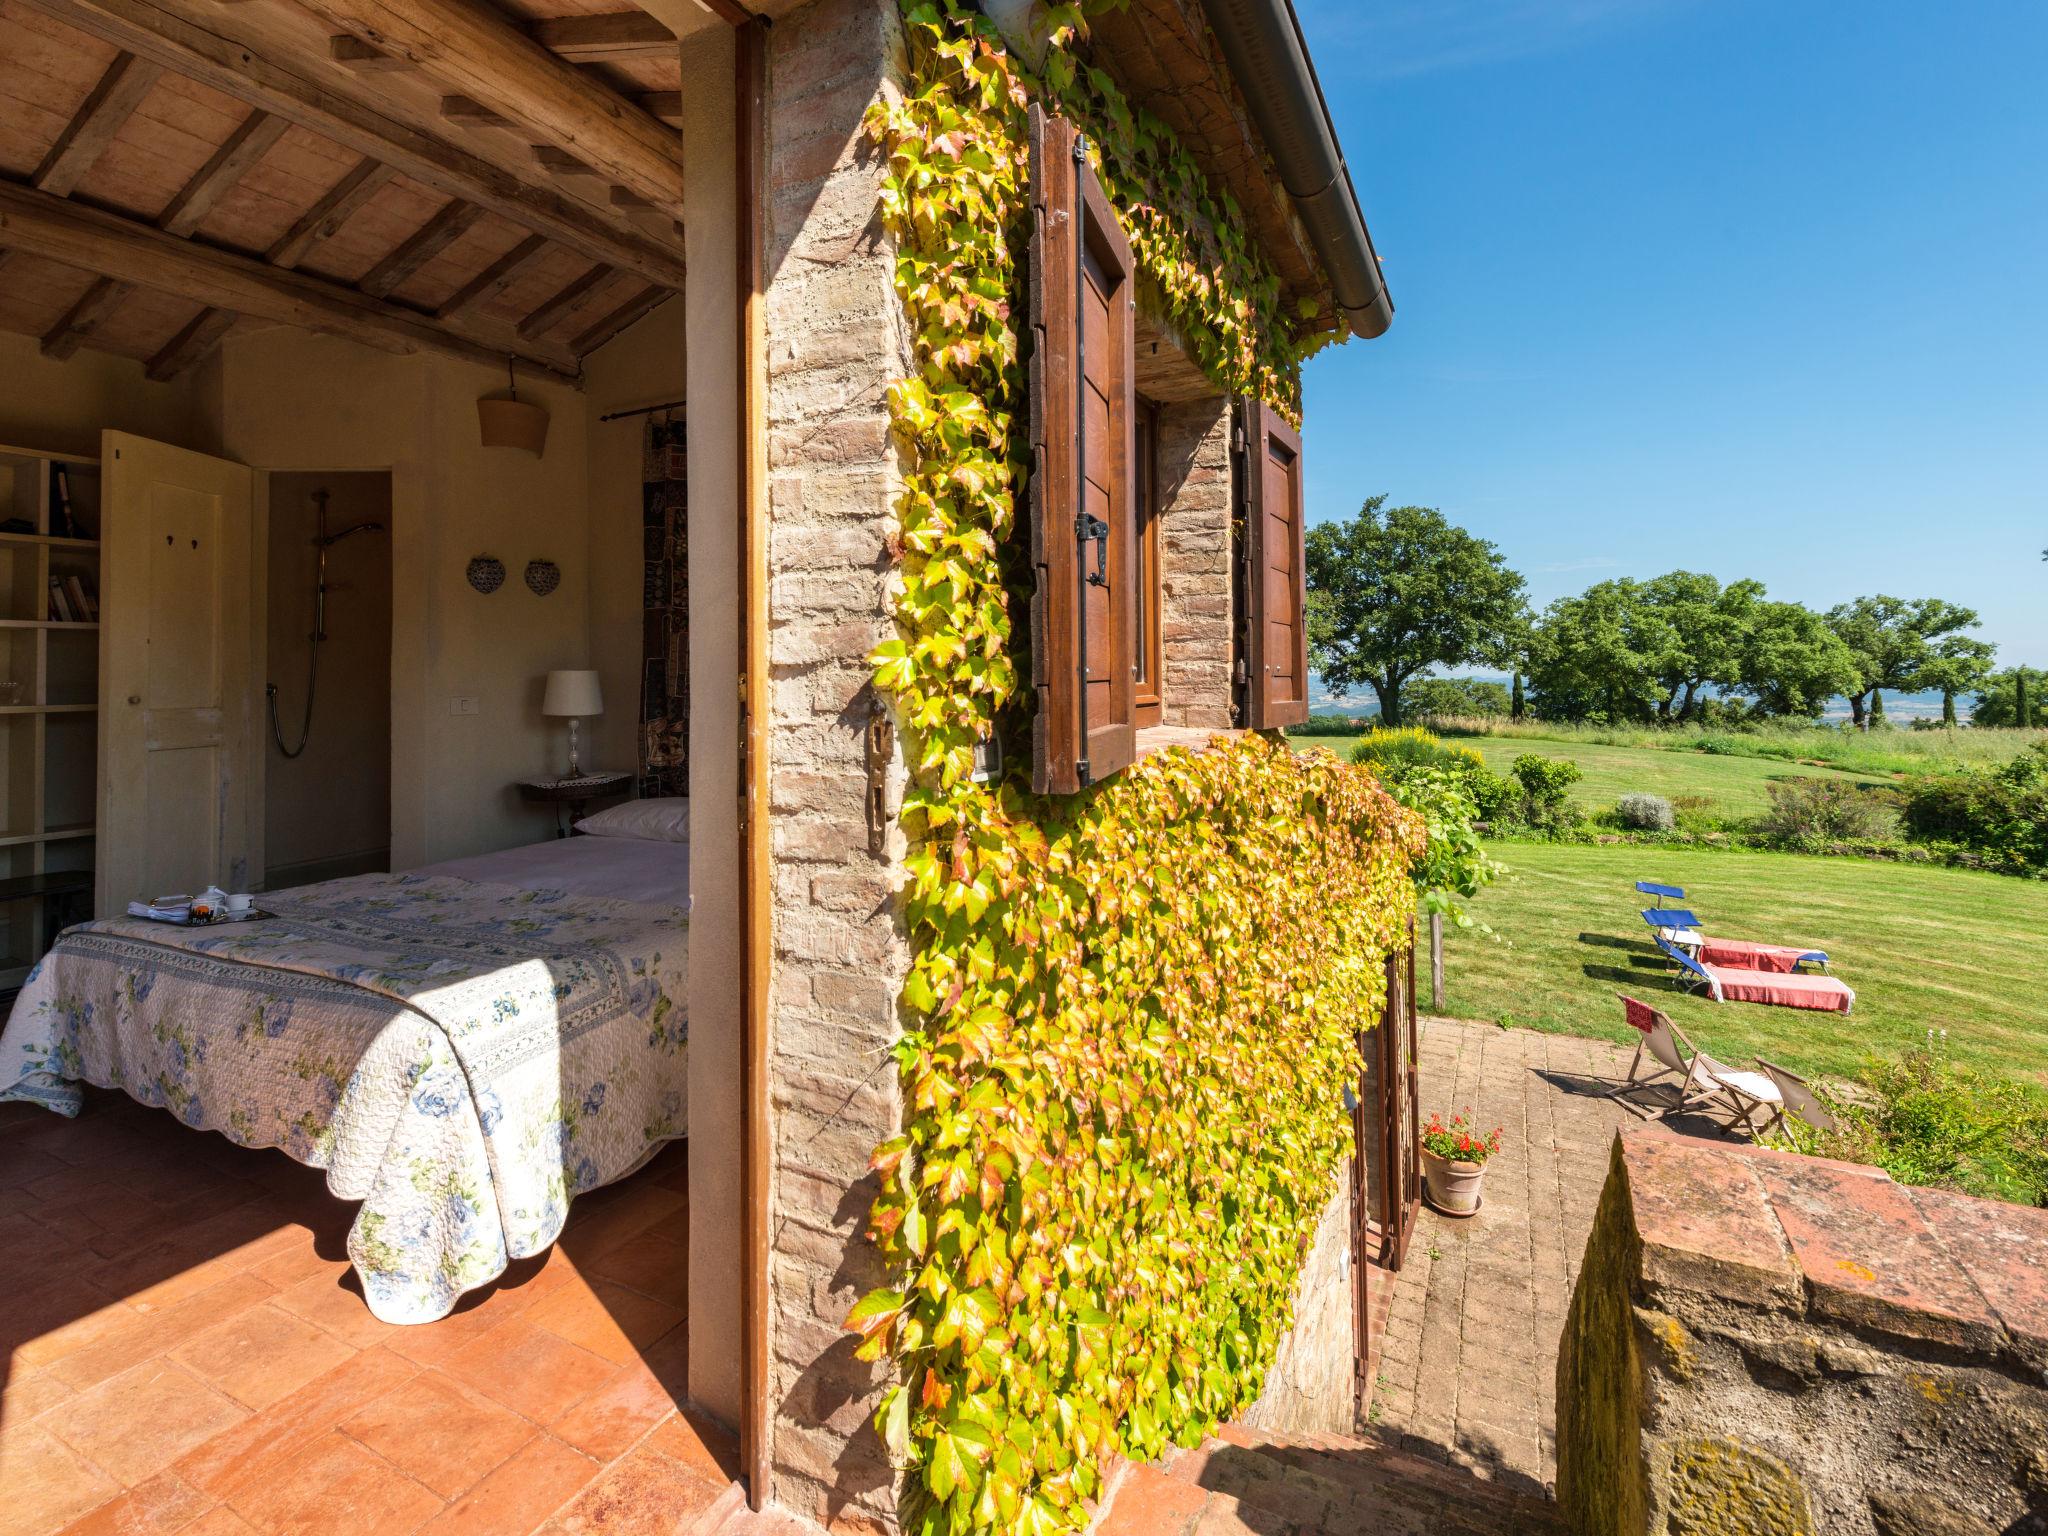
[1239,1157,1358,1436]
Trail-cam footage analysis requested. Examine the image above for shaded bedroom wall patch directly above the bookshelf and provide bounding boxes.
[0,332,207,455]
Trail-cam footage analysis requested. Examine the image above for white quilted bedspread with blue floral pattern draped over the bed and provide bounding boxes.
[0,874,688,1323]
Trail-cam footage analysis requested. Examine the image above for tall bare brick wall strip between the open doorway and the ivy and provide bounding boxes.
[768,0,909,1528]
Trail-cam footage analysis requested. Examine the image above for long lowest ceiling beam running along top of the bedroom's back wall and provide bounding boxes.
[0,182,578,379]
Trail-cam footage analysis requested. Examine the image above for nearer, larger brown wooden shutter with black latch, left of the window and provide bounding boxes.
[1026,106,1137,795]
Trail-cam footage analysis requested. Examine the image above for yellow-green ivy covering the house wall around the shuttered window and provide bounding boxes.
[848,0,1421,1532]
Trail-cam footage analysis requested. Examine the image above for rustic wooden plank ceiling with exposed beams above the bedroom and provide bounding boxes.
[0,0,712,379]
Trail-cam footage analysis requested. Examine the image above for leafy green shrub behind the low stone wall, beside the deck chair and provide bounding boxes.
[1794,1030,2048,1204]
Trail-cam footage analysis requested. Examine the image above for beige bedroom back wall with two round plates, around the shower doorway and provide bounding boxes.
[215,328,590,868]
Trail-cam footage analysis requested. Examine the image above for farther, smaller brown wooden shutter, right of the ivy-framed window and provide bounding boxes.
[1239,399,1309,731]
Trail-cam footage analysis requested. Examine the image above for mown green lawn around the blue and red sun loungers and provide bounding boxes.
[1423,842,2048,1087]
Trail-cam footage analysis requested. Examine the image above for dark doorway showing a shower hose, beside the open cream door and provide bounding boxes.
[262,469,391,891]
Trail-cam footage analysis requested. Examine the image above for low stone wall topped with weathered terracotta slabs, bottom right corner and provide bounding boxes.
[1556,1135,2048,1536]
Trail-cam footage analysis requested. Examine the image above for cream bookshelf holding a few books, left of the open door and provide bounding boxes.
[0,444,100,991]
